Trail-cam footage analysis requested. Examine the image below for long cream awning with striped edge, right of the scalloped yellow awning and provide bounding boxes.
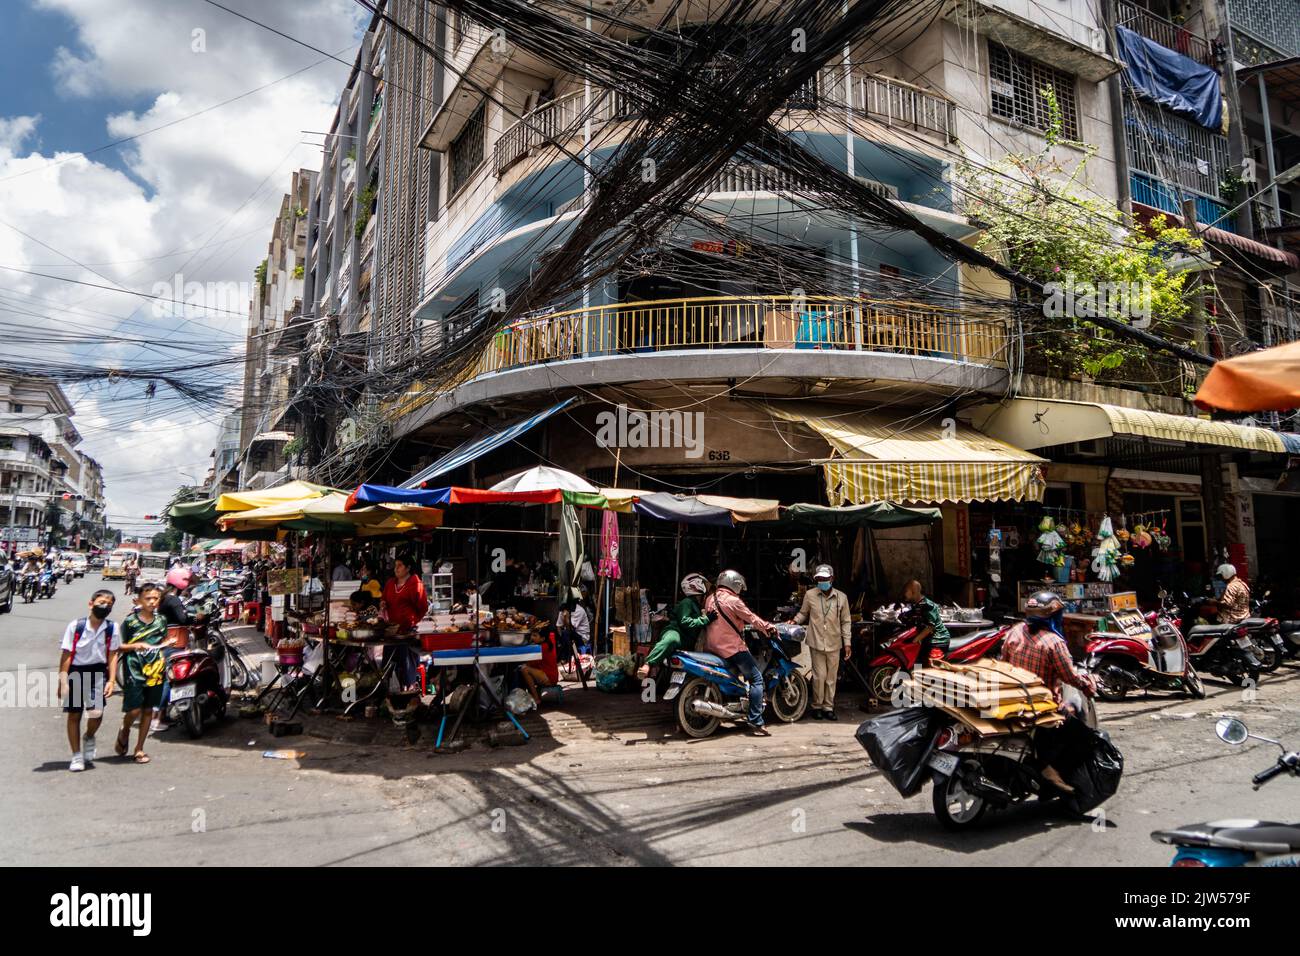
[970,398,1286,454]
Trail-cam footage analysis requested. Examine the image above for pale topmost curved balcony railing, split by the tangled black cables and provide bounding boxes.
[493,66,957,176]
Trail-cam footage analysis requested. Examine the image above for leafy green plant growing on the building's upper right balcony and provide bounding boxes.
[954,90,1203,385]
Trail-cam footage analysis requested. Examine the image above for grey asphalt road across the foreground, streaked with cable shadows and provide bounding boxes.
[0,574,1300,866]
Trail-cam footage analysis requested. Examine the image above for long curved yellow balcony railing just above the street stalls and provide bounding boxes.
[452,295,1008,380]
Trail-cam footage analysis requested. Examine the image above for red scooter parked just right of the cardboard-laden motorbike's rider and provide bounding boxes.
[1083,601,1205,701]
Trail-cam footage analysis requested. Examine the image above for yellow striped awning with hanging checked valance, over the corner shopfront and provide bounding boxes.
[768,405,1047,506]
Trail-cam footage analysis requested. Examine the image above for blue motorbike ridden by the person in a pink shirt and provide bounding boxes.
[663,624,809,737]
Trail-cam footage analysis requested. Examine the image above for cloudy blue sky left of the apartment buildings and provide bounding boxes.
[0,0,369,533]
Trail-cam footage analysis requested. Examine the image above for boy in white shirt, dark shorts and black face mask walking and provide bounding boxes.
[59,589,122,771]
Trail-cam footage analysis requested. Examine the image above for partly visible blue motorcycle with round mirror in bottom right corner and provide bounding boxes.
[1151,717,1300,868]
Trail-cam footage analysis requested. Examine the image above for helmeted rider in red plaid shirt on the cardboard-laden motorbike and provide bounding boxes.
[1002,591,1097,793]
